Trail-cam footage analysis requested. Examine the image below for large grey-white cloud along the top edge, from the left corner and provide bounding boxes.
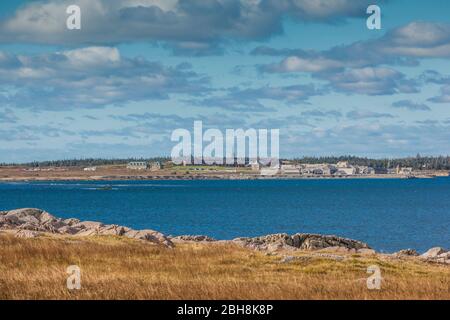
[0,0,384,53]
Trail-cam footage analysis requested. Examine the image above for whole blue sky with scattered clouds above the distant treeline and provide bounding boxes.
[0,0,450,162]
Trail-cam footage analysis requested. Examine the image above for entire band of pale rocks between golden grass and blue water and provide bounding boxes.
[0,208,450,265]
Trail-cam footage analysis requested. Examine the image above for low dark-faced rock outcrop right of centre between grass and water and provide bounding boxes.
[233,233,370,251]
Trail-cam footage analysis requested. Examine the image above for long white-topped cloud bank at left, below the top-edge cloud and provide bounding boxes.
[0,47,209,110]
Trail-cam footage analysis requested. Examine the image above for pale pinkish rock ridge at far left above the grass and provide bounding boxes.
[0,208,173,247]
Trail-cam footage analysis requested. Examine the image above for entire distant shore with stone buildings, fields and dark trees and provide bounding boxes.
[0,155,450,181]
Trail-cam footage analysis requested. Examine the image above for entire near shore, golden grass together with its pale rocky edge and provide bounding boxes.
[0,209,450,300]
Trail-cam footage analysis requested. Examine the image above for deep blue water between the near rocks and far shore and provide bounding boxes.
[0,178,450,252]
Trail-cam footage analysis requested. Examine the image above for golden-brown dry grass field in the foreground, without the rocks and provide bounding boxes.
[0,235,450,299]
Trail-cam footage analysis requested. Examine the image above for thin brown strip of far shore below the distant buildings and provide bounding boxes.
[0,165,449,182]
